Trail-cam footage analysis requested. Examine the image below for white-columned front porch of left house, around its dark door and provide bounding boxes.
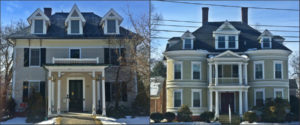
[45,63,107,117]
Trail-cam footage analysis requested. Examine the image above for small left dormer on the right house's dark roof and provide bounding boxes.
[181,31,195,49]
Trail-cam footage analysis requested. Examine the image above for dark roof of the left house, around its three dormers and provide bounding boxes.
[9,12,132,39]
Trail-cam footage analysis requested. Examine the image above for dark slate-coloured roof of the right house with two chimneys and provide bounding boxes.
[166,21,291,52]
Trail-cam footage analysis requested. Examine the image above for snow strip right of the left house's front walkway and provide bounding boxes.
[97,116,150,125]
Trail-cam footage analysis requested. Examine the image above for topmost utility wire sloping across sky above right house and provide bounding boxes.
[161,0,299,12]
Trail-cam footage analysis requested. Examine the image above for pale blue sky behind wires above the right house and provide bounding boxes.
[152,1,299,58]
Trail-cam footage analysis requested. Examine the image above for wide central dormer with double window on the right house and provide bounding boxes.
[213,20,240,49]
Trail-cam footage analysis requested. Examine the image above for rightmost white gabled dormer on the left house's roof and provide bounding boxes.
[100,9,123,35]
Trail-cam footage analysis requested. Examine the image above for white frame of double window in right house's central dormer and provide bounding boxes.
[215,34,239,50]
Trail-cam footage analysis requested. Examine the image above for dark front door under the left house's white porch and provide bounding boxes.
[69,80,83,112]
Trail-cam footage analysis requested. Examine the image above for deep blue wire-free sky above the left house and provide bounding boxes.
[1,1,149,28]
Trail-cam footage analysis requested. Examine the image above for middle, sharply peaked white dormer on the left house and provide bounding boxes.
[65,4,86,35]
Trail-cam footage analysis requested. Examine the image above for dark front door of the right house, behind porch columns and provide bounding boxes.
[221,93,234,113]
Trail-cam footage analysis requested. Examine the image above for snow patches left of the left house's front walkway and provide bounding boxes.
[0,117,55,124]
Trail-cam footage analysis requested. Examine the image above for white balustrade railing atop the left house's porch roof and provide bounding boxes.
[52,57,99,64]
